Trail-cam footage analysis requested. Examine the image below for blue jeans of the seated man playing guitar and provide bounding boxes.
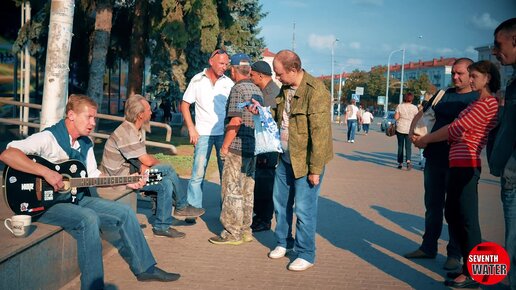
[38,196,156,289]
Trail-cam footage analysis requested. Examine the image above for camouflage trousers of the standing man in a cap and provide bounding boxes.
[220,152,256,240]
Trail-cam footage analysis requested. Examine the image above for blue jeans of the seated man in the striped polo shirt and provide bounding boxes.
[142,164,184,231]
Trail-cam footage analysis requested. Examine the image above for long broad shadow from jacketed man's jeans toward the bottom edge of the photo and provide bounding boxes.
[317,197,445,289]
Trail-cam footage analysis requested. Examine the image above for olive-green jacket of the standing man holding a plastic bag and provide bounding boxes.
[274,71,333,178]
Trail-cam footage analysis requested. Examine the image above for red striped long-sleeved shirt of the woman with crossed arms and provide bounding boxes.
[448,96,498,167]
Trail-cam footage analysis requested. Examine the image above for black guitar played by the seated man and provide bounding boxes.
[3,155,162,216]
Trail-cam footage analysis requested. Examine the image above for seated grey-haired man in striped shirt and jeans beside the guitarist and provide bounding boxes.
[100,95,204,238]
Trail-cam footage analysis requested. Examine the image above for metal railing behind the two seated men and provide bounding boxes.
[0,99,177,155]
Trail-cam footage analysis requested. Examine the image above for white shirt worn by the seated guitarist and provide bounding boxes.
[7,131,100,177]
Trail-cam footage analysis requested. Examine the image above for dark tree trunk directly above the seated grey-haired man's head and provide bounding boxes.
[128,1,149,96]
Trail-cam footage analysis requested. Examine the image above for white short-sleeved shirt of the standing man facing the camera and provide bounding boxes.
[183,69,234,136]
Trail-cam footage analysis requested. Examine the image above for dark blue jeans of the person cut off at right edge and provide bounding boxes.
[501,177,516,289]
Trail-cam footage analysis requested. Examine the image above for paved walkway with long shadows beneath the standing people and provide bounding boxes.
[62,125,508,289]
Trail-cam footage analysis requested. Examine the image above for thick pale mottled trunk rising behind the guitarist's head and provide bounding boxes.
[40,0,75,130]
